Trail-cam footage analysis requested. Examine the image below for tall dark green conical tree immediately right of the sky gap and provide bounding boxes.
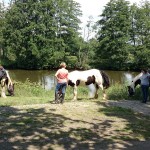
[97,0,131,69]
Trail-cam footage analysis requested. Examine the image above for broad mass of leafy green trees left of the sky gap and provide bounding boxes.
[4,0,80,69]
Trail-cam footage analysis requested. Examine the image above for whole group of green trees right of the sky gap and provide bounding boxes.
[97,0,150,70]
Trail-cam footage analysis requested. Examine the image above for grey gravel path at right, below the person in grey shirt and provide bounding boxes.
[106,100,150,116]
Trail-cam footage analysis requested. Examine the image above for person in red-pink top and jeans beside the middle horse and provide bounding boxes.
[55,62,68,103]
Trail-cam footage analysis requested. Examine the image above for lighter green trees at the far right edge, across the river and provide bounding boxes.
[130,1,150,69]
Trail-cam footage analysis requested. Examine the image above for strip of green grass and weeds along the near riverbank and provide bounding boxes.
[0,80,142,106]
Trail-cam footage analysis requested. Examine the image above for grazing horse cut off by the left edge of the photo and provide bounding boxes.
[0,67,14,98]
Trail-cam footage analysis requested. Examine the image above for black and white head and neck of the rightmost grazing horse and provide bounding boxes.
[128,71,150,96]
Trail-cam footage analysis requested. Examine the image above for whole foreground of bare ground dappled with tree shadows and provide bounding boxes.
[0,101,150,150]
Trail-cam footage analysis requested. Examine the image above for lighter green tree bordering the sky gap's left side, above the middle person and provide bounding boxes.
[52,0,82,67]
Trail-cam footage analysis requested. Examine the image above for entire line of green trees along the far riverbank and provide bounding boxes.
[0,0,150,70]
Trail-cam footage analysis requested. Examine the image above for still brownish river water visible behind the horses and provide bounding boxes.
[8,70,139,90]
